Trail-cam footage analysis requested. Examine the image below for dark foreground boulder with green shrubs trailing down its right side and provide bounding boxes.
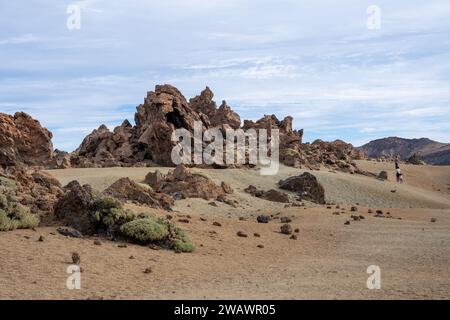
[55,181,194,252]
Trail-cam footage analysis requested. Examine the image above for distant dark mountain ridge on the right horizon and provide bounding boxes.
[357,137,450,165]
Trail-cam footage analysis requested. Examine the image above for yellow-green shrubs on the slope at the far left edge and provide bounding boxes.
[0,176,39,231]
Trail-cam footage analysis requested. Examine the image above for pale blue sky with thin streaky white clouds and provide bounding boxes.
[0,0,450,151]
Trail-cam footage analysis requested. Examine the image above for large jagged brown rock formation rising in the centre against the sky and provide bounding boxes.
[71,85,364,173]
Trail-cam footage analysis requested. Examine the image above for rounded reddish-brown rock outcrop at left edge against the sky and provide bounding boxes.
[0,112,53,167]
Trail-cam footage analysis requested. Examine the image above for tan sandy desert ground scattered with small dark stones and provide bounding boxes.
[0,161,450,299]
